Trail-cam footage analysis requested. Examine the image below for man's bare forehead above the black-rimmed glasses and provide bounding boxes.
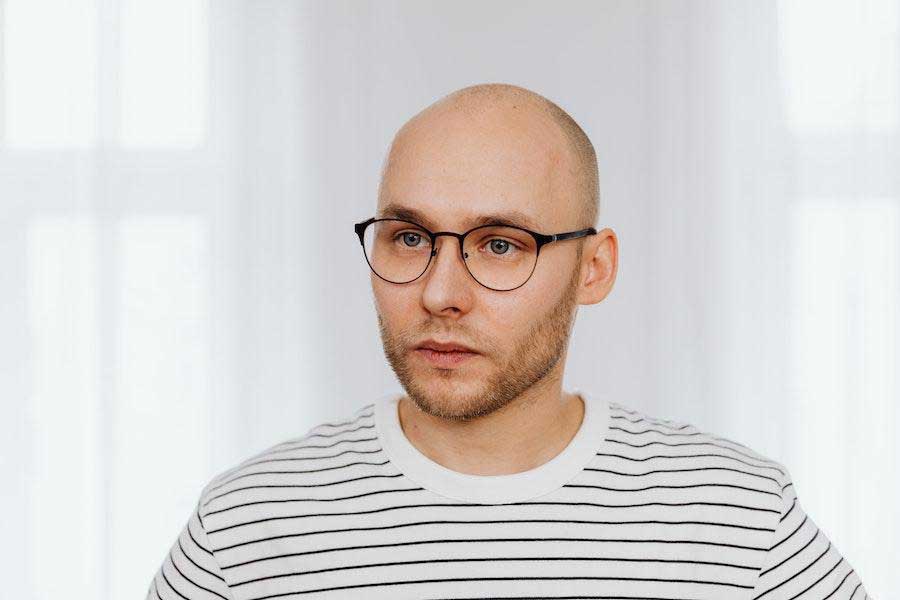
[377,106,571,232]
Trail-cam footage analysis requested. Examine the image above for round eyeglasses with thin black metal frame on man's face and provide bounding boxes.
[353,217,597,292]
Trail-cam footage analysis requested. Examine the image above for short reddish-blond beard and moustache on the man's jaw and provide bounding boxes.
[376,256,581,421]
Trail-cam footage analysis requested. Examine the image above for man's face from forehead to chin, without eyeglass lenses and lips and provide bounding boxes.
[371,102,585,420]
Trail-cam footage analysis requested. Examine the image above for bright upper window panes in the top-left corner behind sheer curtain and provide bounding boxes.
[3,0,209,149]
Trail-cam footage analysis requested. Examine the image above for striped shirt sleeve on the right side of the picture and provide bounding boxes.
[749,464,868,600]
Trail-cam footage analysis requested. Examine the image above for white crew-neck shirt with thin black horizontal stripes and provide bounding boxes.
[147,391,867,600]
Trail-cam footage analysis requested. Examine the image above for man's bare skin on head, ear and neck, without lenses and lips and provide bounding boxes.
[371,84,618,475]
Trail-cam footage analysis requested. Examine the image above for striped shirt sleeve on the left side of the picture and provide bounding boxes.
[146,488,234,600]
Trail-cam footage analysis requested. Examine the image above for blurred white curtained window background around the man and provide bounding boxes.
[0,0,900,600]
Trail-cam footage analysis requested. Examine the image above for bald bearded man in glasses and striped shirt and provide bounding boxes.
[148,84,866,600]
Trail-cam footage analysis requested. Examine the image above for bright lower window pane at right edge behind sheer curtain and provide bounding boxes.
[785,198,900,584]
